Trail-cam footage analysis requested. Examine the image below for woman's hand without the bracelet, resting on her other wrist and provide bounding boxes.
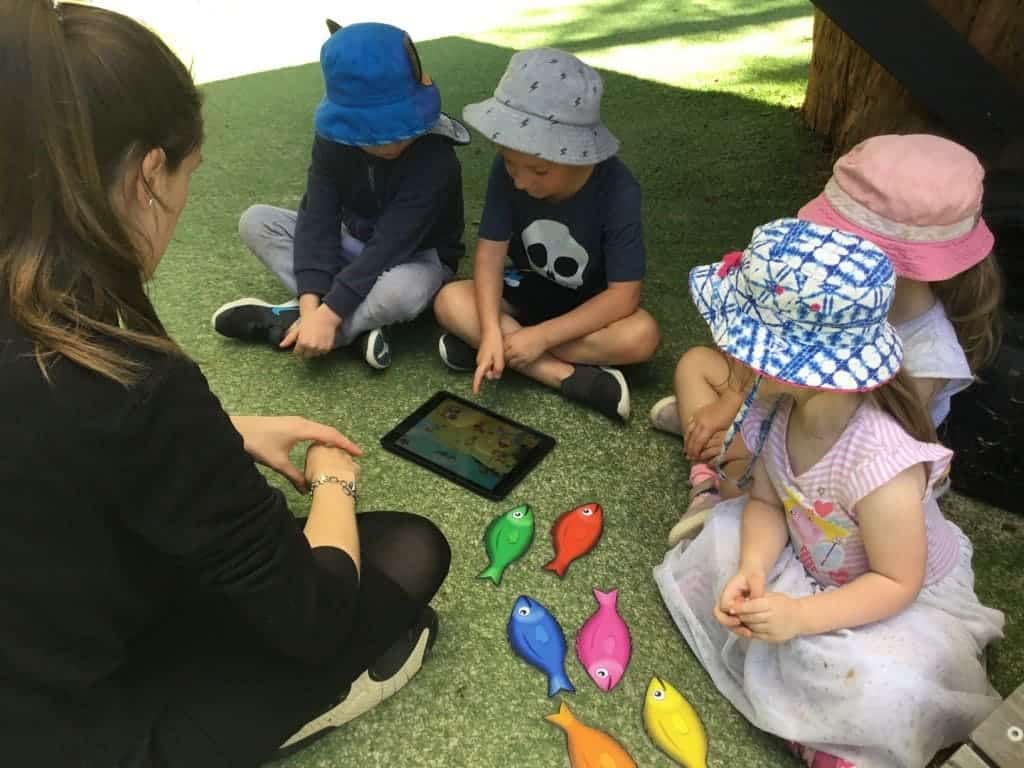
[231,416,362,494]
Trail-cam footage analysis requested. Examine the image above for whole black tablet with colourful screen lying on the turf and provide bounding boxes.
[381,392,555,502]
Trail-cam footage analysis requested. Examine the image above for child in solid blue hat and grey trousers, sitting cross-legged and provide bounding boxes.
[213,23,469,370]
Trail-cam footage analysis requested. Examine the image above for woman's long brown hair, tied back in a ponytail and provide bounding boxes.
[0,0,203,385]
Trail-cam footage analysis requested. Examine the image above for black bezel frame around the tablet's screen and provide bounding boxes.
[381,390,555,502]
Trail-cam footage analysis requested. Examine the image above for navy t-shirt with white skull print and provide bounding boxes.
[480,155,646,306]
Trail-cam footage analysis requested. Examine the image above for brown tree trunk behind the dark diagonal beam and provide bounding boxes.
[804,0,1024,170]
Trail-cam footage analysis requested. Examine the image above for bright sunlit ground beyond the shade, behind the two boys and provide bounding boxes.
[81,0,812,105]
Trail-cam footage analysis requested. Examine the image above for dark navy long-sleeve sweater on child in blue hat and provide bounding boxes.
[295,134,465,317]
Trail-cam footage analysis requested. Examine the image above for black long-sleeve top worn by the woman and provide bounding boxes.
[0,305,358,765]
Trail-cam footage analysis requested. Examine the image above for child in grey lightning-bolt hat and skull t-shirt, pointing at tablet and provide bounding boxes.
[434,48,658,421]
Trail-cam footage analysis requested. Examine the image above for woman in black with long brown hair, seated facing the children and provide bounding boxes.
[0,0,450,768]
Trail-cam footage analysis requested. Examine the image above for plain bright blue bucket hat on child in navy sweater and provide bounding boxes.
[313,23,470,146]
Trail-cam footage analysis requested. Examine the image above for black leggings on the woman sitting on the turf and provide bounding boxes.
[122,512,451,768]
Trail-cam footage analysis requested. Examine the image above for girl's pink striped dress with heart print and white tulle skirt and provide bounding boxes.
[654,401,1004,768]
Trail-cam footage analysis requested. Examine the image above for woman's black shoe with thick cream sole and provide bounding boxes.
[279,605,437,757]
